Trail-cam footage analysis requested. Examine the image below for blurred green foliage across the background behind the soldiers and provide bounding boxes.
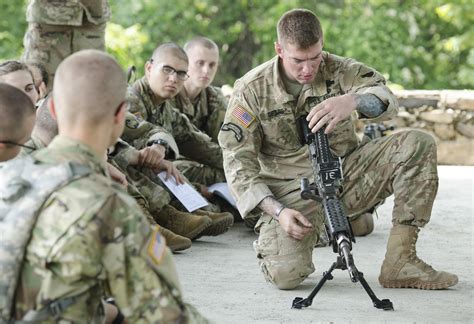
[0,0,474,89]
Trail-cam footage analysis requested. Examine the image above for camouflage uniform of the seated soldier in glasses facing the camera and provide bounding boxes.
[122,77,225,185]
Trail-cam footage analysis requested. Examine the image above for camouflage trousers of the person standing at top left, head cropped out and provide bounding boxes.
[22,21,106,90]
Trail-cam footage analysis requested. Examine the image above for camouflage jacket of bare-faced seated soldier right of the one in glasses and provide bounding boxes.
[173,86,227,143]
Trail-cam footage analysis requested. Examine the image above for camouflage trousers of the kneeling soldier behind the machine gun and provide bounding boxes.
[254,131,438,289]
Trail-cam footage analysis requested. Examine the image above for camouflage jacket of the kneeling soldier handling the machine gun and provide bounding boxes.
[219,52,398,217]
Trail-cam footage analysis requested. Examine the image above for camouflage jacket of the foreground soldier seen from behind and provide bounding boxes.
[16,136,206,323]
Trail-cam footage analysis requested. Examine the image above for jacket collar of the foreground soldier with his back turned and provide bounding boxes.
[47,135,107,175]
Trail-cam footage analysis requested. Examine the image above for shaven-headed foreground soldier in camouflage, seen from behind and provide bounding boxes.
[15,50,205,323]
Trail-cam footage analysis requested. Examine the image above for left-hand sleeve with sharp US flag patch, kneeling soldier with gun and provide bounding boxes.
[218,81,272,217]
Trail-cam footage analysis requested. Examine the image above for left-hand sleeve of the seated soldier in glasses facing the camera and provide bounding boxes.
[121,90,179,158]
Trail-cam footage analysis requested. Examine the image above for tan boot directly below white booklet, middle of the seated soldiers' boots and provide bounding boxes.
[156,205,212,240]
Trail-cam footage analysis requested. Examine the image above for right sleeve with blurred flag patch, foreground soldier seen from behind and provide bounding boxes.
[100,194,202,323]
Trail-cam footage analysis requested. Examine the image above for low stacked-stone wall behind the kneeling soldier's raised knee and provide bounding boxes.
[358,90,474,165]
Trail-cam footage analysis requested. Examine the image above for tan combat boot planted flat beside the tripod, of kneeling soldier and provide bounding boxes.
[379,225,458,290]
